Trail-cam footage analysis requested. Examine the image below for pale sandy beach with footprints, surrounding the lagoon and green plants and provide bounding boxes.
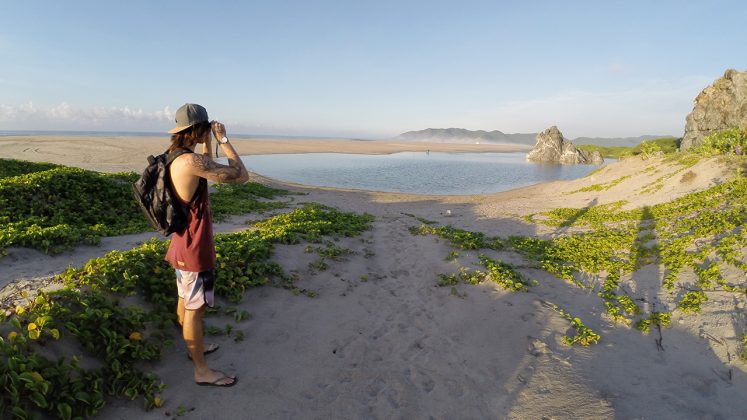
[0,136,747,419]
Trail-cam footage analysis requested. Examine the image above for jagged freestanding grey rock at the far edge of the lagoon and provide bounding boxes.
[527,126,604,165]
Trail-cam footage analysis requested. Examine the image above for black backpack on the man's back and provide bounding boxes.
[132,149,191,236]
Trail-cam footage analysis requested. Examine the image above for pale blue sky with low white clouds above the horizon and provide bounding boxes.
[0,0,747,138]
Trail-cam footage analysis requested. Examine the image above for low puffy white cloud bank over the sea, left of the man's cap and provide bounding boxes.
[0,102,174,131]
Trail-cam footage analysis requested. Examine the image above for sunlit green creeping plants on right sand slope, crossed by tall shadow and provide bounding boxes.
[532,173,747,313]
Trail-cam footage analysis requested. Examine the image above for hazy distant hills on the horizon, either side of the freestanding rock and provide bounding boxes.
[397,128,674,146]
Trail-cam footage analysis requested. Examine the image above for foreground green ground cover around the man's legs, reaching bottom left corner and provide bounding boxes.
[0,204,373,419]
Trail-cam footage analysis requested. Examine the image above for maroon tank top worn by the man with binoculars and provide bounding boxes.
[164,178,215,272]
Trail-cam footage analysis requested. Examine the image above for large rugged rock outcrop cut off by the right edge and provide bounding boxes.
[680,70,747,150]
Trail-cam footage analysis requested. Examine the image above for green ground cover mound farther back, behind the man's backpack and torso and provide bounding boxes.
[0,159,288,256]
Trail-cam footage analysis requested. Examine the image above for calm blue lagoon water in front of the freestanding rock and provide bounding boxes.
[242,152,599,195]
